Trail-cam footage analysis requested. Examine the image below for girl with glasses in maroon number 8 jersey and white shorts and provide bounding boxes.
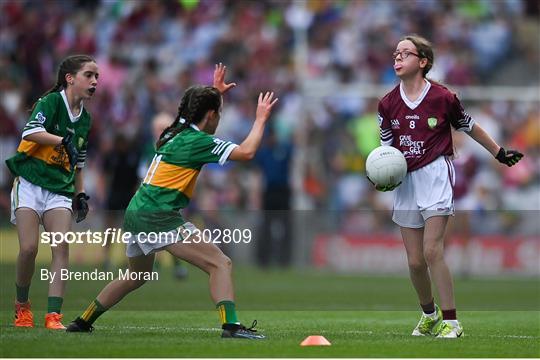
[377,35,523,338]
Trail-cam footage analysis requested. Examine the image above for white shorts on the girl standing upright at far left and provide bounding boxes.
[11,176,72,224]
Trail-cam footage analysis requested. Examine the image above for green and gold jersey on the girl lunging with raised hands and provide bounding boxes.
[124,125,237,233]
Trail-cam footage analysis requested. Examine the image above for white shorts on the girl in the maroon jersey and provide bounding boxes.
[392,156,455,228]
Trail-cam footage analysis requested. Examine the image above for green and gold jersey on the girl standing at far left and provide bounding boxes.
[6,90,91,197]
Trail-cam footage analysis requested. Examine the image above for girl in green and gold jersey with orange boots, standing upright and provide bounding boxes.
[6,55,99,329]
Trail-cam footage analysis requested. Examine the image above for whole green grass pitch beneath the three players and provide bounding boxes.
[0,264,540,358]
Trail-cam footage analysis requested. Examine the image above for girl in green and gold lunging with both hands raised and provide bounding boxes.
[67,64,277,339]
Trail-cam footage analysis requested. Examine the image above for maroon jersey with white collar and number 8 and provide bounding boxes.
[378,80,474,172]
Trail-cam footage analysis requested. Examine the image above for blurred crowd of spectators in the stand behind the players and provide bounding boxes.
[0,0,540,256]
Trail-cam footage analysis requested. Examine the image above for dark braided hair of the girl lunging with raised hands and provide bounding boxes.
[156,85,221,149]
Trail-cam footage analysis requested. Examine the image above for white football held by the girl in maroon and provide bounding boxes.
[366,146,407,186]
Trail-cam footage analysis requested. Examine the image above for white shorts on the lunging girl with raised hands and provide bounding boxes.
[126,222,198,257]
